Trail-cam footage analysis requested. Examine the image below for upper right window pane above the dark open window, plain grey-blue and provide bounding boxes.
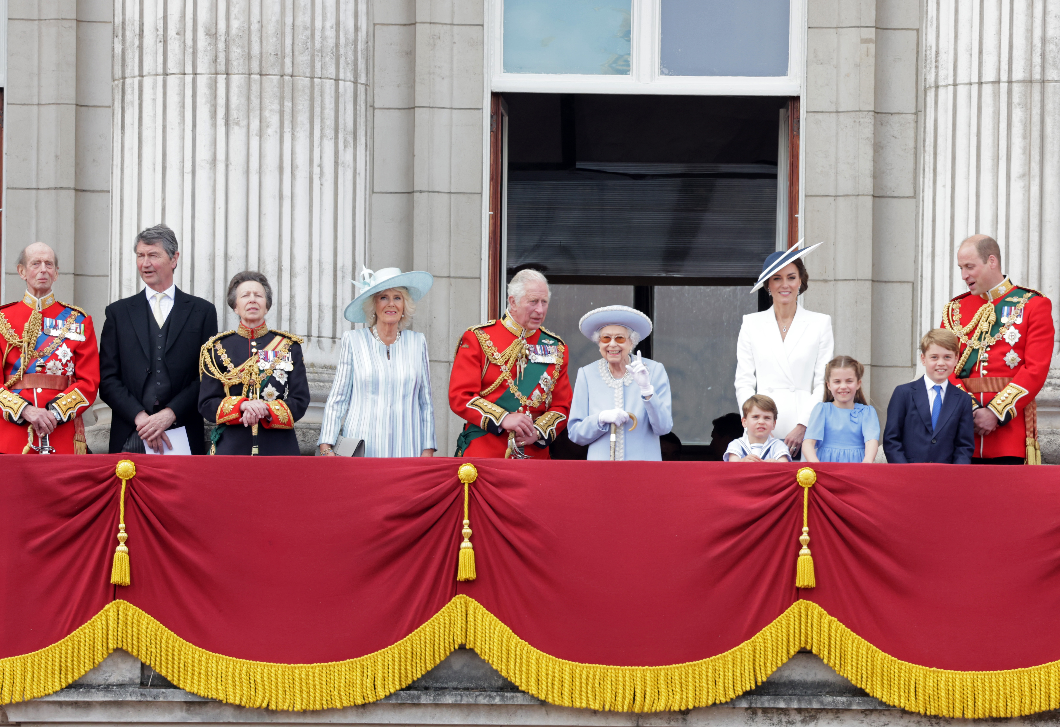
[661,0,790,76]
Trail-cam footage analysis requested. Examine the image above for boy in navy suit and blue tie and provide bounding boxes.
[883,329,975,464]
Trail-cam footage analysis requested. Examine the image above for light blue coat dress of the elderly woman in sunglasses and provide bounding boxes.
[567,358,673,460]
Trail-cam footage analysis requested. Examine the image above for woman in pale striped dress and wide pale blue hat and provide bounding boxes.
[317,268,437,457]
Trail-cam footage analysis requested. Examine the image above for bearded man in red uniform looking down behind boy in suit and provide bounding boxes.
[942,235,1054,464]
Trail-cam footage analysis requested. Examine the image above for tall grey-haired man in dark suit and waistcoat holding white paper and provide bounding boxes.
[100,225,217,455]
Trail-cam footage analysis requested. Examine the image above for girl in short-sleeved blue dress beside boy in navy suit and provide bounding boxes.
[802,356,880,462]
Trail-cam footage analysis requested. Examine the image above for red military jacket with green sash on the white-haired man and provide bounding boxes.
[449,313,573,459]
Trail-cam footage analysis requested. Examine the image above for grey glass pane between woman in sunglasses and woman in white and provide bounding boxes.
[652,285,758,444]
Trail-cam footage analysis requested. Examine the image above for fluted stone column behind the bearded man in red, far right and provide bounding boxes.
[918,0,1060,462]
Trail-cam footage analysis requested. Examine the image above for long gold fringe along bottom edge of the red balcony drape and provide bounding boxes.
[6,596,1060,719]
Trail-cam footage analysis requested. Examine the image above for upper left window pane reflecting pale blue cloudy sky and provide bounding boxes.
[504,0,631,75]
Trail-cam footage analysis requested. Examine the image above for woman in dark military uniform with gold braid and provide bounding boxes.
[198,271,310,456]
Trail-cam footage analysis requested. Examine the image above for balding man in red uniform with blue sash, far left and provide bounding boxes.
[0,243,100,455]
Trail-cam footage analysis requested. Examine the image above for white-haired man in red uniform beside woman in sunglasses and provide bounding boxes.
[449,270,572,459]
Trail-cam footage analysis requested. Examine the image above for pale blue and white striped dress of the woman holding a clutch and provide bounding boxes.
[317,329,437,457]
